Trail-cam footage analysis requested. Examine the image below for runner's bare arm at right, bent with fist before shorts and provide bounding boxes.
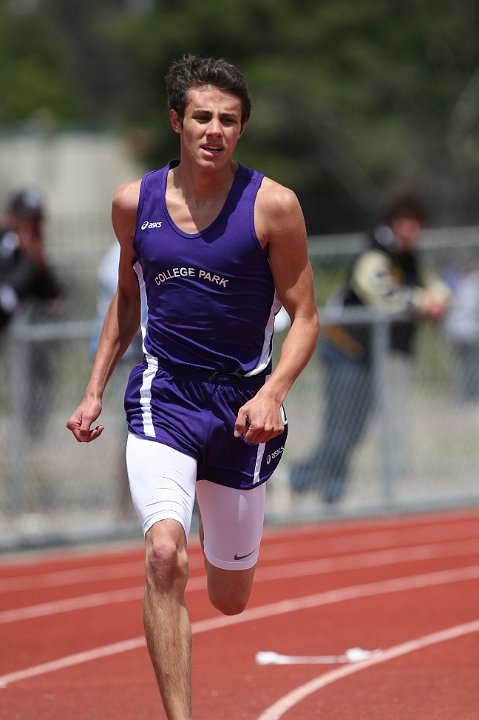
[235,178,319,443]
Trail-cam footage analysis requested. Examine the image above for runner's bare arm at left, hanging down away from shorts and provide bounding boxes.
[67,181,140,442]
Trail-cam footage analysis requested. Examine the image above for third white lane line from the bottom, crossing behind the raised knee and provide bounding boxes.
[0,540,479,625]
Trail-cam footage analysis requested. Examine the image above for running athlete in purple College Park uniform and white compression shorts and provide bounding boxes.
[67,55,319,720]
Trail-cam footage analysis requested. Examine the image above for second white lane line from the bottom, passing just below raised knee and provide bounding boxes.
[0,565,479,688]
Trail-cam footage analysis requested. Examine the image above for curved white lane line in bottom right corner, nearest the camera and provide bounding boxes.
[257,620,479,720]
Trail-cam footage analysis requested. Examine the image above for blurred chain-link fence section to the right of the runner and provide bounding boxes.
[270,311,479,521]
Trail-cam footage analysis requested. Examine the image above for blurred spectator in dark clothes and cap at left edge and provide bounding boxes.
[0,189,62,438]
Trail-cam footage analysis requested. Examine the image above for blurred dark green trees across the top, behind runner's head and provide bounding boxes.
[0,0,479,232]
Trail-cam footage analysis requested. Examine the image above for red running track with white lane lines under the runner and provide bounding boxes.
[0,509,479,720]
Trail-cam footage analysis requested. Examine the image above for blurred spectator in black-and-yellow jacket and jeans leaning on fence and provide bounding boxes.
[290,193,449,503]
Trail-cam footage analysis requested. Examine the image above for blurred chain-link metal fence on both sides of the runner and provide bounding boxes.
[0,229,479,549]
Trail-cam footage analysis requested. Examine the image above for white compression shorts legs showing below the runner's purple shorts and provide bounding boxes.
[126,433,266,570]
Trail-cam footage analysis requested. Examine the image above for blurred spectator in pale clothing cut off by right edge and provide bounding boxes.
[444,262,479,402]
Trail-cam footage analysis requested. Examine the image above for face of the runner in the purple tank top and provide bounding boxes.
[171,85,244,169]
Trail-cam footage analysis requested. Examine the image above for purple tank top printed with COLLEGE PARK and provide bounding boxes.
[133,161,281,376]
